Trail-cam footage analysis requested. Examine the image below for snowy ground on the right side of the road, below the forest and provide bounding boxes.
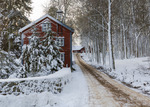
[82,54,150,95]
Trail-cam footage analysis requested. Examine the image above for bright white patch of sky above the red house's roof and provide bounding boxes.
[29,0,50,21]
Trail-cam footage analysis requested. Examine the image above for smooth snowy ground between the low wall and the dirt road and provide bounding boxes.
[0,57,88,107]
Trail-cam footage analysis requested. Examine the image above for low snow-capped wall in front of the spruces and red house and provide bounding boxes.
[0,68,71,95]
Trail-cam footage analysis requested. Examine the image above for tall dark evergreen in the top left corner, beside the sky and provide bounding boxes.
[0,0,32,51]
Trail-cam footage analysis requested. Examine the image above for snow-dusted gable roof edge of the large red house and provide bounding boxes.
[19,14,74,33]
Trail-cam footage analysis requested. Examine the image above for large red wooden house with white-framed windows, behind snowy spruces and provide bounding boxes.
[19,15,74,67]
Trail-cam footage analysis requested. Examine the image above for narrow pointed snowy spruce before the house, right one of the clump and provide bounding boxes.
[42,31,63,73]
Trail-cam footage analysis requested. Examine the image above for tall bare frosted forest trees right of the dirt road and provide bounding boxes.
[76,0,150,68]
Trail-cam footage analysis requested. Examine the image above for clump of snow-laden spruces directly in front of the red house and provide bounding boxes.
[22,28,63,76]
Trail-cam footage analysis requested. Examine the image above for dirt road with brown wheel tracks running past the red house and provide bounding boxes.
[76,54,150,107]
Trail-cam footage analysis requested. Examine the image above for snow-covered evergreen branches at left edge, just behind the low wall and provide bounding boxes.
[0,50,26,79]
